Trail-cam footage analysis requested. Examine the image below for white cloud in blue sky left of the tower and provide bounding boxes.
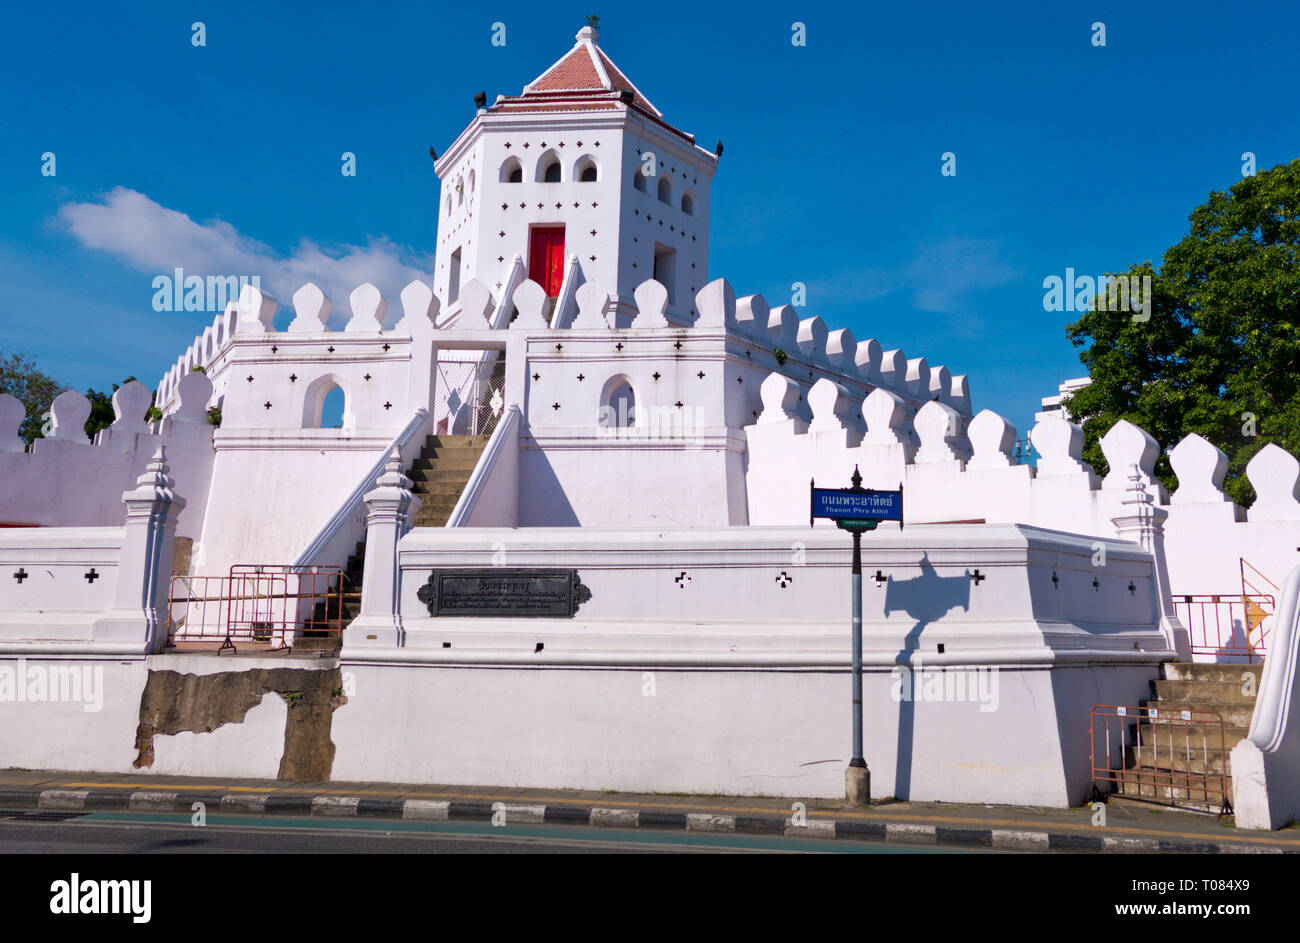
[59,187,433,321]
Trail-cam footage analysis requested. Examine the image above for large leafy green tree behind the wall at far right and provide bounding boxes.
[1065,159,1300,503]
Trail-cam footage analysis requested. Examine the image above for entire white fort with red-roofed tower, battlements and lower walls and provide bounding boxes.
[0,27,1300,825]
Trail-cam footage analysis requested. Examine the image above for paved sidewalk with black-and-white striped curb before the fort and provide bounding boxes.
[0,770,1300,853]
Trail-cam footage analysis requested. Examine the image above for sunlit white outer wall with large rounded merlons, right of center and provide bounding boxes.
[745,392,1300,593]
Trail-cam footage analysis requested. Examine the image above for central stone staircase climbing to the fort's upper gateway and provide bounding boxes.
[294,436,489,652]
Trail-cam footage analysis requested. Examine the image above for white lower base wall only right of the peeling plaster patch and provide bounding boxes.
[333,663,1157,806]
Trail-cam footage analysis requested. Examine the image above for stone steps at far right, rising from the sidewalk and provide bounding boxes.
[1115,662,1264,812]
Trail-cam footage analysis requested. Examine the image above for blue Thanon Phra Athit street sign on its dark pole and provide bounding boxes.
[809,466,902,805]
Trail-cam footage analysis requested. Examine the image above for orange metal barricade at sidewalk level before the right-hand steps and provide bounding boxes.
[1088,704,1232,814]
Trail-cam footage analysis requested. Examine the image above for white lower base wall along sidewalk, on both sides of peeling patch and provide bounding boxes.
[0,656,1156,806]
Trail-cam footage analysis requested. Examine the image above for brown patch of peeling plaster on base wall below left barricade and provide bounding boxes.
[134,666,347,780]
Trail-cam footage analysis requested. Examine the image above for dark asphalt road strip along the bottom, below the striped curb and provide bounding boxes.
[0,812,977,855]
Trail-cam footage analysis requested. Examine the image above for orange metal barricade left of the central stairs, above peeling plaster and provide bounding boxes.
[168,563,343,652]
